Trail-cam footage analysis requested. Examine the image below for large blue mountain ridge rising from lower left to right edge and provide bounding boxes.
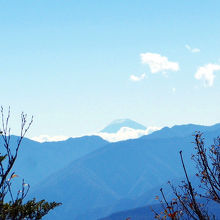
[27,124,220,220]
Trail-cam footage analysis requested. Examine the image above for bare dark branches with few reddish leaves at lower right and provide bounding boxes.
[153,133,220,220]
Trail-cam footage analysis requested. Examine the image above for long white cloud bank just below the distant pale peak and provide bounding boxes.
[95,127,161,142]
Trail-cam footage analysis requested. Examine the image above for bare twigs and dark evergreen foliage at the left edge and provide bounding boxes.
[0,107,61,219]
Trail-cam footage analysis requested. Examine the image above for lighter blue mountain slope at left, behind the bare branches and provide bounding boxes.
[7,136,108,186]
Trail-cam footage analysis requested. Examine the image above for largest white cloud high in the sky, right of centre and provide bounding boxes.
[140,53,179,73]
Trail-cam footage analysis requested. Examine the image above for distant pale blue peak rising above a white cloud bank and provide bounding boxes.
[100,119,147,133]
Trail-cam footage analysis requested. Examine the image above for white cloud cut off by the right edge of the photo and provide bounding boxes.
[195,63,220,87]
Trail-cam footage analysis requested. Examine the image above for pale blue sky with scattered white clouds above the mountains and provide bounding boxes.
[0,0,220,139]
